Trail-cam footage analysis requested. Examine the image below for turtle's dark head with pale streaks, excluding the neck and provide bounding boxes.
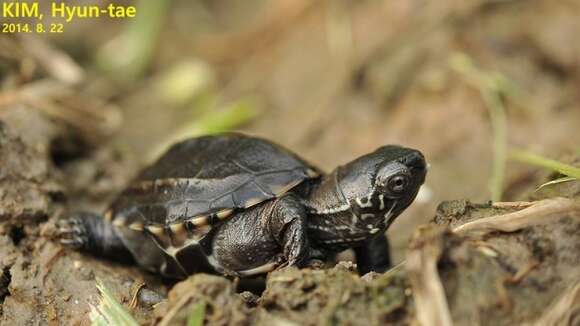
[337,145,427,232]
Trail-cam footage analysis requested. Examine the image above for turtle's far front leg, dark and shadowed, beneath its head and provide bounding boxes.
[354,233,391,275]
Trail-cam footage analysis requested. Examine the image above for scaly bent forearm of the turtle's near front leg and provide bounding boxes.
[269,195,310,267]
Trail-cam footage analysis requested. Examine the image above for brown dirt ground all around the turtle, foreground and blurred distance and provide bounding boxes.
[0,0,580,325]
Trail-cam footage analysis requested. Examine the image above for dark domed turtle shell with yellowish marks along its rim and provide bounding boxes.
[105,133,320,256]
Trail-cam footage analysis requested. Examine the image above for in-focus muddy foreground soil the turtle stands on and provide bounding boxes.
[0,106,580,325]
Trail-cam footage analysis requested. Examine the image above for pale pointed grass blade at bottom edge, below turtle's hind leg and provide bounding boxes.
[90,278,139,326]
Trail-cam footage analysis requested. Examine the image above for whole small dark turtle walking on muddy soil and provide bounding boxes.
[58,132,427,278]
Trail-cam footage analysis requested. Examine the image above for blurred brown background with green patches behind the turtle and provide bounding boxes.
[0,0,580,260]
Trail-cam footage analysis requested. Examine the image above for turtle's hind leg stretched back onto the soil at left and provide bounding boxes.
[57,212,133,262]
